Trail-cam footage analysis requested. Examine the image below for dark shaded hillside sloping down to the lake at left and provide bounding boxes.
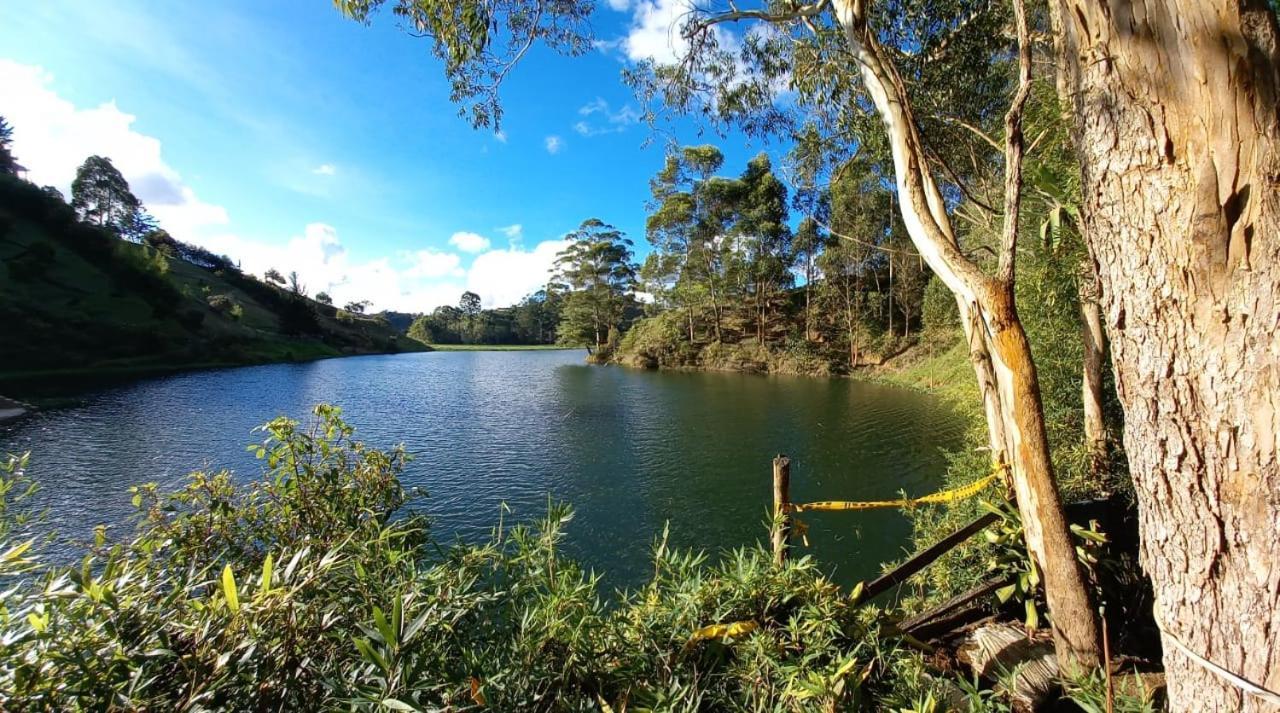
[0,175,429,381]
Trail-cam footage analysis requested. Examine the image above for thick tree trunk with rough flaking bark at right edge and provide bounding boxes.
[1051,0,1280,710]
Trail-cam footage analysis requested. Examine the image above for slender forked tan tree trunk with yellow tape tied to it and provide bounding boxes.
[832,0,1101,671]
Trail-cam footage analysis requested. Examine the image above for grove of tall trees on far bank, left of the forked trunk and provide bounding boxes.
[632,146,929,370]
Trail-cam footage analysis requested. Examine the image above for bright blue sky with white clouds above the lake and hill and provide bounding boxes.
[0,0,777,311]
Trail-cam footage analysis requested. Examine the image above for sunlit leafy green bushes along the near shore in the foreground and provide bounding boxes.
[0,406,952,710]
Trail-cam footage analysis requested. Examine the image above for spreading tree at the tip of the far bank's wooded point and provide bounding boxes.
[556,218,636,349]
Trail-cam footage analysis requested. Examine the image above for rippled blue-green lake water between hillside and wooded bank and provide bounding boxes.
[0,351,963,586]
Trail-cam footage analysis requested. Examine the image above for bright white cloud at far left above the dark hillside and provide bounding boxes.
[0,60,228,239]
